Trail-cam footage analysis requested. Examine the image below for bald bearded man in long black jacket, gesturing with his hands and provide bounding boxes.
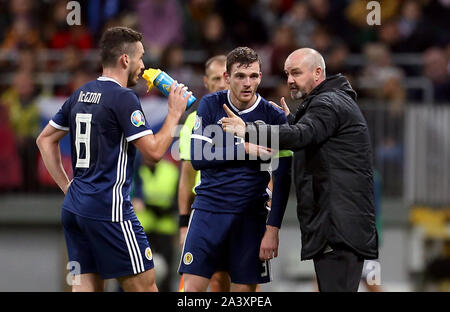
[222,48,378,291]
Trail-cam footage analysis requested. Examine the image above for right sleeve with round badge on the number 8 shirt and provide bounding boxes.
[113,90,153,142]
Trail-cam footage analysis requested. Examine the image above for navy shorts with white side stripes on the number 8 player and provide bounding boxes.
[61,209,154,279]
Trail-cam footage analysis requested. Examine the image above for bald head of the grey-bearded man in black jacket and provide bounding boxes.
[284,48,325,100]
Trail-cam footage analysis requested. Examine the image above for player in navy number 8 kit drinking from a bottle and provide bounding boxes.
[37,27,191,291]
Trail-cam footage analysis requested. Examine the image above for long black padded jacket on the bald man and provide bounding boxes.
[246,74,378,260]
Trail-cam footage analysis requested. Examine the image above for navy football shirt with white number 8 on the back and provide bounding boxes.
[50,77,153,222]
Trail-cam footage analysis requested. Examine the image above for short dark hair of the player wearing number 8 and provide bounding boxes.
[100,27,142,67]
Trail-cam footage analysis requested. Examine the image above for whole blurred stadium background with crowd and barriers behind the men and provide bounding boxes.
[0,0,450,291]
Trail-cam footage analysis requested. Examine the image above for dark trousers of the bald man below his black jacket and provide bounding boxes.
[313,246,364,292]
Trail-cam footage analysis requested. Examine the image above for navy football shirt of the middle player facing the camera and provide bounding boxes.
[191,90,292,227]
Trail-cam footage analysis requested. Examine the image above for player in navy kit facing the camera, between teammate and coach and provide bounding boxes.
[179,47,291,292]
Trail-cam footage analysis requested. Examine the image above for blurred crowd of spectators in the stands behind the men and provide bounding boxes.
[0,0,450,192]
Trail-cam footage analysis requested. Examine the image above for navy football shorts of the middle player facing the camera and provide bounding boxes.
[178,209,271,284]
